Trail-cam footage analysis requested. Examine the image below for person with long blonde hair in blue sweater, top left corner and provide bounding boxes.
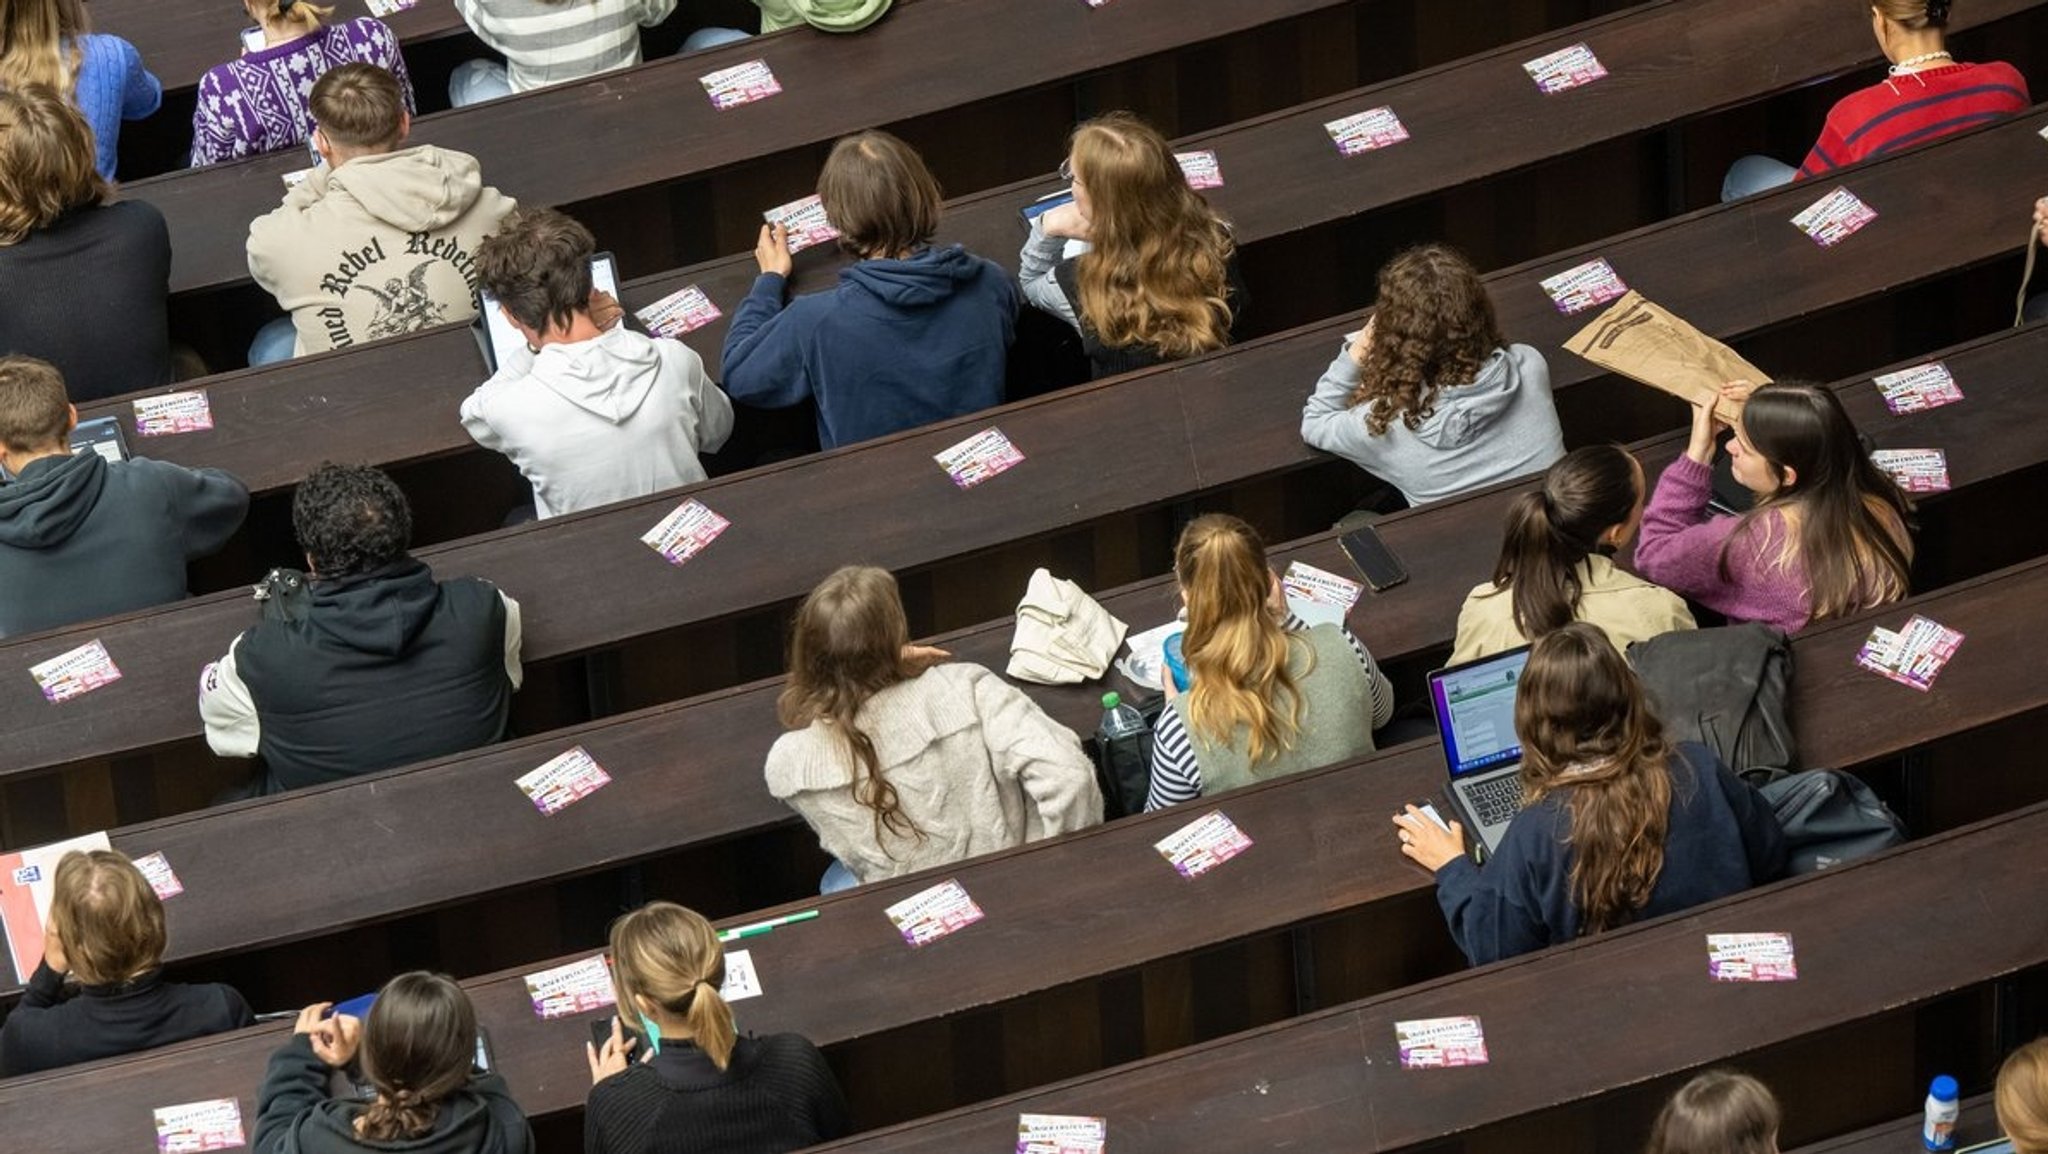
[0,0,164,180]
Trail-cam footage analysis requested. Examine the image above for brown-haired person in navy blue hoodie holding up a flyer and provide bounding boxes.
[725,131,1018,449]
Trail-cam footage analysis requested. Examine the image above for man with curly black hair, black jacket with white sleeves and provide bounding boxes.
[199,463,520,793]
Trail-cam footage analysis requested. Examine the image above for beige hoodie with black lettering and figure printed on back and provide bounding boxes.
[248,143,516,357]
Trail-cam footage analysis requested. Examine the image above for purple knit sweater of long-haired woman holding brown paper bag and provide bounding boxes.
[1636,457,1812,633]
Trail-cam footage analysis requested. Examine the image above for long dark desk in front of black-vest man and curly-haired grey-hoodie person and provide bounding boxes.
[24,111,2048,787]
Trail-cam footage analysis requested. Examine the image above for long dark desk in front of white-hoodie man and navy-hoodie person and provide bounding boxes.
[88,0,2036,492]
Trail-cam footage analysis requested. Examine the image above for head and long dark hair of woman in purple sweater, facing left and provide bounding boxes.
[1720,381,1913,619]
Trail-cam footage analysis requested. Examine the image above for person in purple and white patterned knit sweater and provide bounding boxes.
[193,0,418,168]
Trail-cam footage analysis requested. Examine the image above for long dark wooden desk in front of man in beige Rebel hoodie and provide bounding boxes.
[125,0,1368,293]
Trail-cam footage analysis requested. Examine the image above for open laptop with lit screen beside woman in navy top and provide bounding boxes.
[1430,646,1530,855]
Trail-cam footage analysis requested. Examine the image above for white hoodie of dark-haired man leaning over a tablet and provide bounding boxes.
[463,324,733,517]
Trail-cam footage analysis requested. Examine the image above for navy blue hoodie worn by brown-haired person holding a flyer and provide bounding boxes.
[725,244,1018,449]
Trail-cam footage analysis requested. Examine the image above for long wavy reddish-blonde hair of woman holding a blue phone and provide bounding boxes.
[1069,113,1231,361]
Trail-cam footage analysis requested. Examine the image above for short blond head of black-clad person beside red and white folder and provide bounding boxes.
[43,849,164,986]
